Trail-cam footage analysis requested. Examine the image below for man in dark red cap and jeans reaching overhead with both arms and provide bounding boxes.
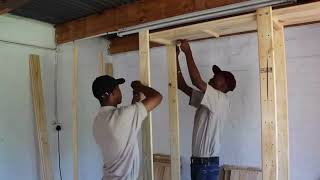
[177,40,236,180]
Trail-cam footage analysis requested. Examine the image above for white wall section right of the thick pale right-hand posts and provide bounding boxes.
[286,24,320,180]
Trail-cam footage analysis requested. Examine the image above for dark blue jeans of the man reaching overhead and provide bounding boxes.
[191,158,219,180]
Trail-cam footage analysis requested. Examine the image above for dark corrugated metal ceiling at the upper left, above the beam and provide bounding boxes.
[11,0,135,24]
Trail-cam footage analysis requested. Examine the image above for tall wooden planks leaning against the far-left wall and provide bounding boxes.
[29,55,53,180]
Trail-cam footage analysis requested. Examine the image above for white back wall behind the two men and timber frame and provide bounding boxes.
[113,24,320,180]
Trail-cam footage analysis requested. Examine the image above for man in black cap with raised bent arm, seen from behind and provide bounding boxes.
[92,75,162,180]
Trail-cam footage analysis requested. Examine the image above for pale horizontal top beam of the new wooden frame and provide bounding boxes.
[150,2,320,43]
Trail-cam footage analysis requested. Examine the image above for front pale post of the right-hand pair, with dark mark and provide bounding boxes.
[257,7,278,180]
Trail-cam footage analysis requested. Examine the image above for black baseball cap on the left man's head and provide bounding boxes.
[92,75,125,99]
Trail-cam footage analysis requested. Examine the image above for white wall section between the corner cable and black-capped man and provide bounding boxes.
[56,38,106,180]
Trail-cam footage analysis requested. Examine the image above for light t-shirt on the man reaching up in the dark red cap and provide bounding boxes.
[190,84,230,157]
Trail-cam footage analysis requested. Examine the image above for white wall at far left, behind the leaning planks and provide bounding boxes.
[0,16,56,180]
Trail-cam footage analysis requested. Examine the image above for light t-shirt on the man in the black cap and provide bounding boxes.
[93,102,148,180]
